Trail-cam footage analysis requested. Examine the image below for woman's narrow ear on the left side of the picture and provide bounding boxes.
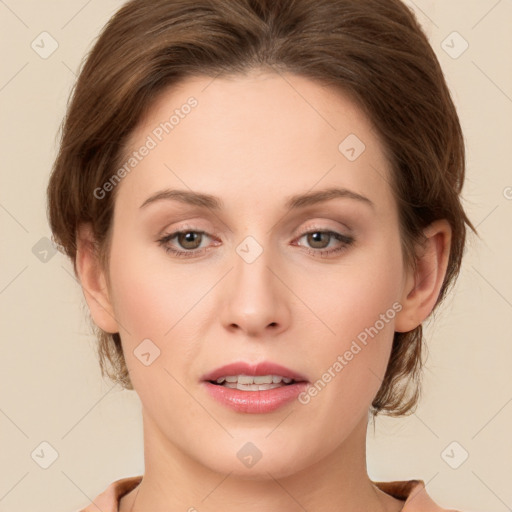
[76,223,119,333]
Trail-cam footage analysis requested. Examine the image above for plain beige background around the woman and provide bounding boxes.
[0,0,512,512]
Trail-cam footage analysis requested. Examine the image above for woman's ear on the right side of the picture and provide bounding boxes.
[395,219,452,332]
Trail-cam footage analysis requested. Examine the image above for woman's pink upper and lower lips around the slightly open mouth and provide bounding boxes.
[202,362,309,414]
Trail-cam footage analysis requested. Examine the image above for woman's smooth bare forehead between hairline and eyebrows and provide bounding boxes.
[118,72,391,216]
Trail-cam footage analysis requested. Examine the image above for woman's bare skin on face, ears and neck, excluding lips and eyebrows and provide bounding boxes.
[77,70,451,512]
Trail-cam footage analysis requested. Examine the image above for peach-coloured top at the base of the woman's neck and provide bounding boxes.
[79,475,458,512]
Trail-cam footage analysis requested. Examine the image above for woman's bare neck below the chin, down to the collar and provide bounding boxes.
[119,413,403,512]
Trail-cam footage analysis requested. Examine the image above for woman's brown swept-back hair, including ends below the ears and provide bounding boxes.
[48,0,476,416]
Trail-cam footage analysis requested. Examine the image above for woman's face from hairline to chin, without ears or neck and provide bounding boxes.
[91,72,412,478]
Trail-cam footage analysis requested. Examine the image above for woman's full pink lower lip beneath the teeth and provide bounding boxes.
[204,382,308,414]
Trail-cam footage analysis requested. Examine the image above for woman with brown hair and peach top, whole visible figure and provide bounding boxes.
[48,0,474,512]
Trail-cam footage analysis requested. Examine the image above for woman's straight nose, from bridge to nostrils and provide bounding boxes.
[220,241,291,337]
